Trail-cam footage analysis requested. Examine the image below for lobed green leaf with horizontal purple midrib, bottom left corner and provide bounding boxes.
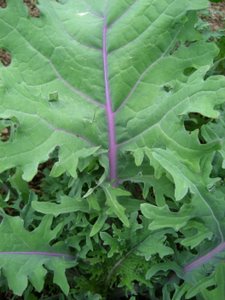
[0,215,74,295]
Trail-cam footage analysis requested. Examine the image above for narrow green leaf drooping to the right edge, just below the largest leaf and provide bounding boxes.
[148,149,225,241]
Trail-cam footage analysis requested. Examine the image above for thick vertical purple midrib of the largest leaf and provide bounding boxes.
[102,17,117,185]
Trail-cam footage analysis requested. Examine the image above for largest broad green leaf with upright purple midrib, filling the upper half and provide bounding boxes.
[0,0,225,185]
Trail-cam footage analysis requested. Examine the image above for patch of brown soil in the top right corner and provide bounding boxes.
[206,1,225,31]
